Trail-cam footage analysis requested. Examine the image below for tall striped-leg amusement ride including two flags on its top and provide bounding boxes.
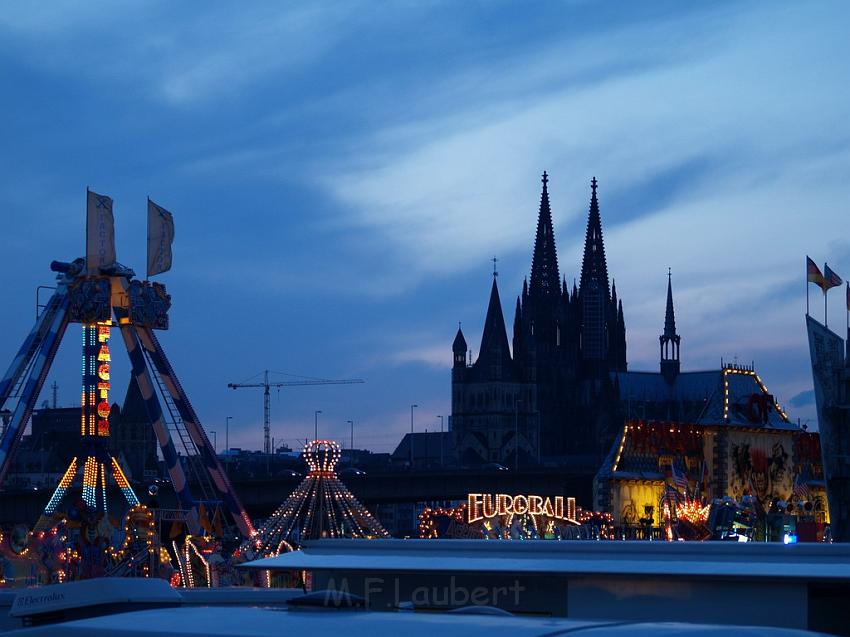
[0,192,256,538]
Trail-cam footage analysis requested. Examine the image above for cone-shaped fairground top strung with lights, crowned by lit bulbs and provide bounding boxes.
[242,440,389,557]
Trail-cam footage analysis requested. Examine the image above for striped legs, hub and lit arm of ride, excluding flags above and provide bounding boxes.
[0,259,255,538]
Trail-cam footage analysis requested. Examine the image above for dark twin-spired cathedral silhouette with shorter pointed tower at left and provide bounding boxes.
[451,172,626,472]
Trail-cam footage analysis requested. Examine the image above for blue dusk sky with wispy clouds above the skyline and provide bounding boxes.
[0,1,850,451]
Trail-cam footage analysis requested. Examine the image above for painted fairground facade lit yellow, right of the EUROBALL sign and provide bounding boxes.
[594,365,829,541]
